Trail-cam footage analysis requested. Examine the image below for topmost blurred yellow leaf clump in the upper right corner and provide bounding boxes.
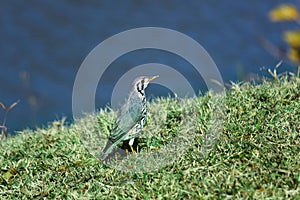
[269,4,299,22]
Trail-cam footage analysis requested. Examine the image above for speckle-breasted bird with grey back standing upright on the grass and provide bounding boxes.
[100,75,159,161]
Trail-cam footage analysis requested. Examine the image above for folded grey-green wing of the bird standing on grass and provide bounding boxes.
[109,97,143,142]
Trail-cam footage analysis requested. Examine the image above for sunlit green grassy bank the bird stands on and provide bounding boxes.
[0,76,300,199]
